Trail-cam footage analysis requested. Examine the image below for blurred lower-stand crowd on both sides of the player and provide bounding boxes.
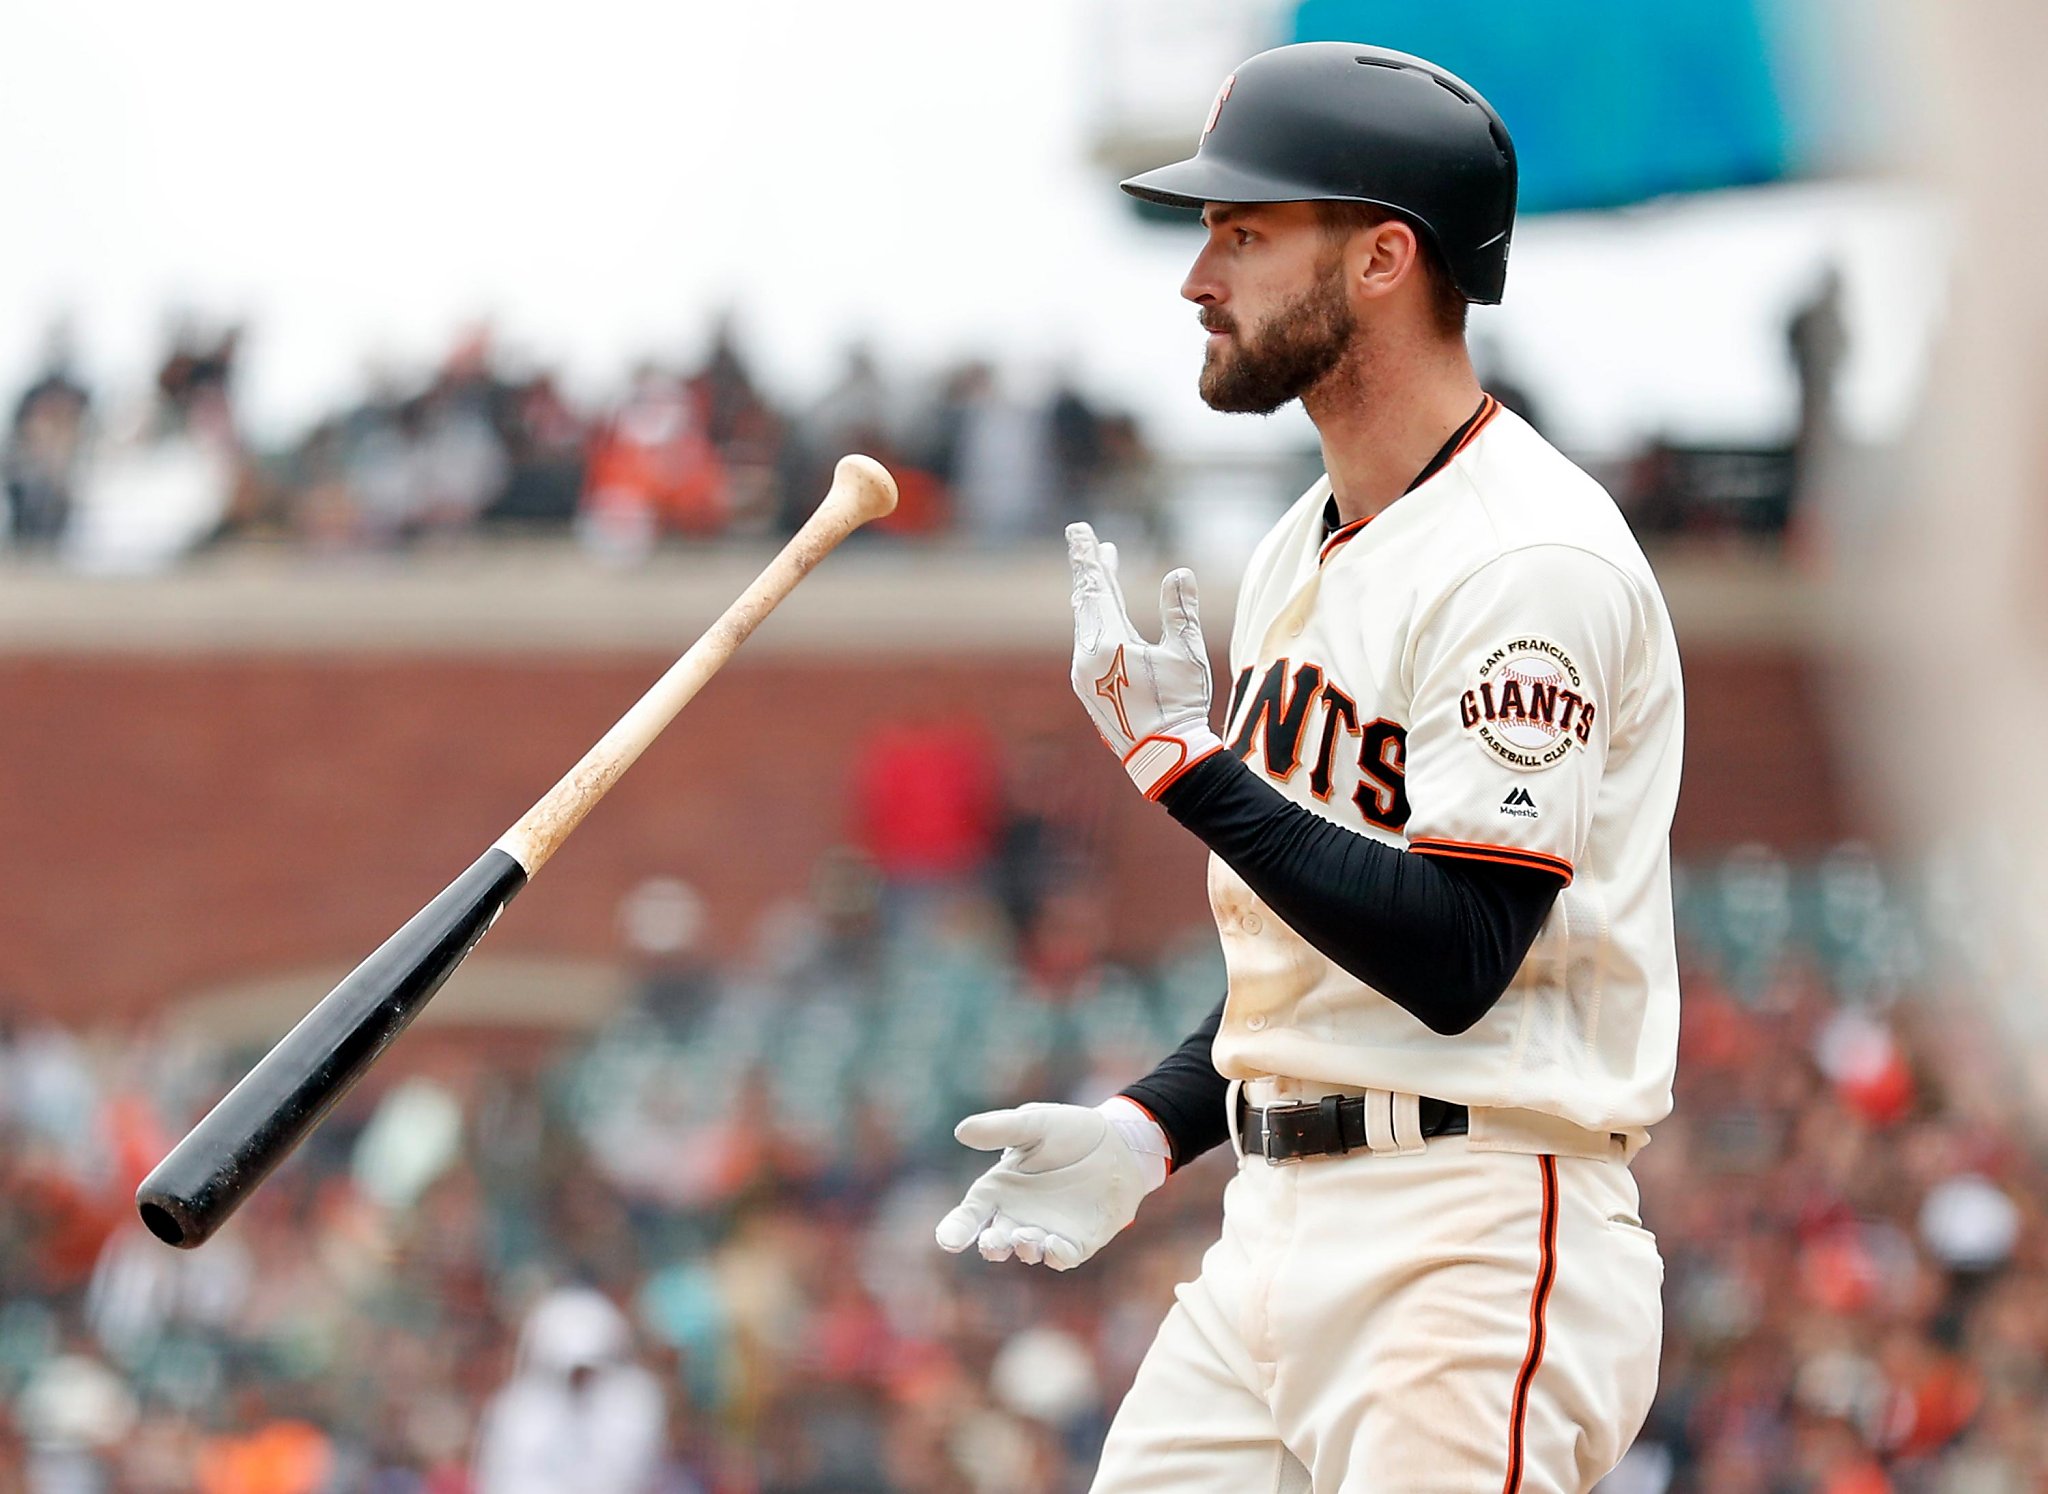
[0,850,2048,1494]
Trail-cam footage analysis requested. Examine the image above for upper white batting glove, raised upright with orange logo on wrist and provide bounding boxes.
[1067,525,1223,799]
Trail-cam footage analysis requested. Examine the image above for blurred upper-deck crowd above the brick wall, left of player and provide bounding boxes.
[0,322,1157,574]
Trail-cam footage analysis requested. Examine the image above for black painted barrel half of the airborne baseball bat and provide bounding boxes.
[135,846,526,1250]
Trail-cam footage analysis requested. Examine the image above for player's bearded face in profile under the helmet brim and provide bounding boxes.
[1180,203,1358,414]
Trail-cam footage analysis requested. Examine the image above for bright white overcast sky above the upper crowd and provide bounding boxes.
[0,0,1939,451]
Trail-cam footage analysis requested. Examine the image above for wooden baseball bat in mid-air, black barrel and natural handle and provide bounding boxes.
[135,457,897,1250]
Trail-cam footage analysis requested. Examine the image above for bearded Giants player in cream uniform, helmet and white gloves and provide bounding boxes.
[938,43,1681,1494]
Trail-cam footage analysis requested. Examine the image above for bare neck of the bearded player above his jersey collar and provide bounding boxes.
[1303,338,1481,523]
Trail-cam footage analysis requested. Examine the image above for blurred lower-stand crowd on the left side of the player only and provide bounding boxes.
[0,815,1221,1494]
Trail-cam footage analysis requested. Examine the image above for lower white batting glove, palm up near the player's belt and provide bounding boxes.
[936,1096,1167,1271]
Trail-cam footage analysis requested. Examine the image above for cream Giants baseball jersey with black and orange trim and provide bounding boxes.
[1208,400,1683,1133]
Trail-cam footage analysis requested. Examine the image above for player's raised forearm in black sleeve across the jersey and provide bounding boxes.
[1161,754,1559,1033]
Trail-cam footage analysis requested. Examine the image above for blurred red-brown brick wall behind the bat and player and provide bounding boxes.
[0,648,1851,1023]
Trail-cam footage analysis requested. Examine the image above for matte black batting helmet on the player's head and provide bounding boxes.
[1122,41,1516,305]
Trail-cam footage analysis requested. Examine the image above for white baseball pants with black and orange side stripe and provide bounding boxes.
[1094,1117,1663,1494]
